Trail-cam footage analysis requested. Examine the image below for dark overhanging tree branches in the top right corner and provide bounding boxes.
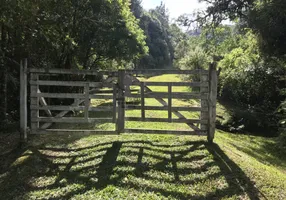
[197,0,286,59]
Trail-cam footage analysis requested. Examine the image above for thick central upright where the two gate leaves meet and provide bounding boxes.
[116,70,125,134]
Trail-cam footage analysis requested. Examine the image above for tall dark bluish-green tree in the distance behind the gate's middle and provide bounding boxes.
[132,0,177,69]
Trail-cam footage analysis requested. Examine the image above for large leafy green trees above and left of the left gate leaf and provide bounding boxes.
[0,0,148,126]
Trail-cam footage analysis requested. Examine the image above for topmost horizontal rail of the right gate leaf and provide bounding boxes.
[126,69,208,75]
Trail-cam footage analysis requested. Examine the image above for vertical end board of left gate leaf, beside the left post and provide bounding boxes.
[30,73,39,134]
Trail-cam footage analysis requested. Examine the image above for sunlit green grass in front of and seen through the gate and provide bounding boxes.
[0,76,286,200]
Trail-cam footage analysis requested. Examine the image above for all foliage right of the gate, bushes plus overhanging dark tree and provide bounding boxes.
[178,0,286,140]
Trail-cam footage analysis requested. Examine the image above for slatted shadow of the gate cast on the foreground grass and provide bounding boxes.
[0,140,260,199]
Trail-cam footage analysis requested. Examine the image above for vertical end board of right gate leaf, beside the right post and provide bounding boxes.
[200,69,209,135]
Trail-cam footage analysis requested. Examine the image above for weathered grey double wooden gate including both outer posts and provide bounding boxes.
[20,62,217,141]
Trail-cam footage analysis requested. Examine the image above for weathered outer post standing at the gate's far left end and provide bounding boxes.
[20,59,28,142]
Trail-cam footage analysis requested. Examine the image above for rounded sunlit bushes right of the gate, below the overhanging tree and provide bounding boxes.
[176,26,285,136]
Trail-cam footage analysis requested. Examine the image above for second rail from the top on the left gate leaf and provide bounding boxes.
[30,80,113,87]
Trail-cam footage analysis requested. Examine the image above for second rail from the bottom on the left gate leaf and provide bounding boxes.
[31,117,112,124]
